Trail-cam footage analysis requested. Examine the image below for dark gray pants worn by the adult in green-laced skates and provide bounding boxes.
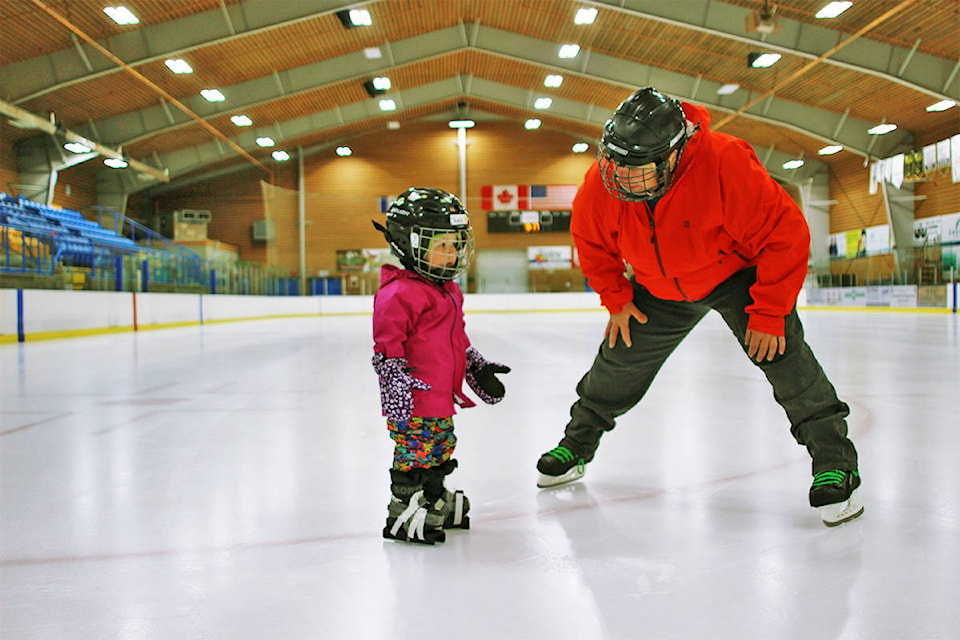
[561,269,857,474]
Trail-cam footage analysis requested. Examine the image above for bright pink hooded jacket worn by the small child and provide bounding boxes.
[373,265,476,417]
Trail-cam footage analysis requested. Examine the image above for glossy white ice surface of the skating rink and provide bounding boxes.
[0,311,960,640]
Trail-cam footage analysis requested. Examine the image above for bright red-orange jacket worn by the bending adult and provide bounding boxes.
[570,103,810,336]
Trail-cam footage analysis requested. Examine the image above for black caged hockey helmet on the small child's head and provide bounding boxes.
[374,187,474,282]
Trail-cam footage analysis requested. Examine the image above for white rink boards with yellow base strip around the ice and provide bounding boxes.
[0,284,957,343]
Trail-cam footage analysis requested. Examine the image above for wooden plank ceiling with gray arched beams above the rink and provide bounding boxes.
[0,0,960,188]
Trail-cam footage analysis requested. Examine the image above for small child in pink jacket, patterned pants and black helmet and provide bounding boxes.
[373,188,510,544]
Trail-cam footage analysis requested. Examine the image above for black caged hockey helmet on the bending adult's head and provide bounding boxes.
[597,87,693,202]
